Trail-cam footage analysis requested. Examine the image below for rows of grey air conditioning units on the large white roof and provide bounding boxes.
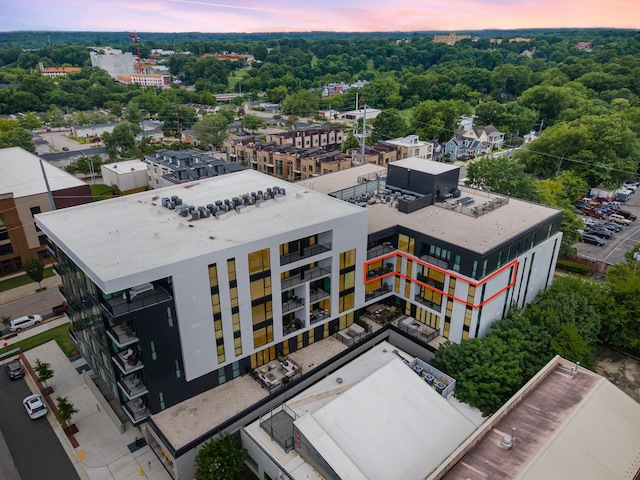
[162,187,286,220]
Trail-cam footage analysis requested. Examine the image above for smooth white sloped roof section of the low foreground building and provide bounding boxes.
[295,354,475,480]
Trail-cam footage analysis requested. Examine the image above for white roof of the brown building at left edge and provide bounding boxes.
[0,147,86,198]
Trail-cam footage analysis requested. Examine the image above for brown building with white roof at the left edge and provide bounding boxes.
[0,147,92,276]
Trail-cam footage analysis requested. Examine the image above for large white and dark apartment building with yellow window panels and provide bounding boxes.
[37,158,562,444]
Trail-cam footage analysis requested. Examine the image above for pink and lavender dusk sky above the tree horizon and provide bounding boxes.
[0,0,640,33]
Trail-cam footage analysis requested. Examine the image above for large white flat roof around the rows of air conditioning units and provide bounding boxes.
[36,170,366,293]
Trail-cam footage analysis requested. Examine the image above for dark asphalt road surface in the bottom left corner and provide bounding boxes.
[0,370,80,480]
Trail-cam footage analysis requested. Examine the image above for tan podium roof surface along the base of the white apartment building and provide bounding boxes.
[151,337,347,450]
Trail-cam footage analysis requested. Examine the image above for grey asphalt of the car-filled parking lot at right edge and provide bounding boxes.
[576,185,640,264]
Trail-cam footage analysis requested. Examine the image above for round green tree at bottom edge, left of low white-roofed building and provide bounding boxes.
[196,432,247,480]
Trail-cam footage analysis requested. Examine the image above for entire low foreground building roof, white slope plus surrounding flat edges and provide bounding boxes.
[246,341,476,480]
